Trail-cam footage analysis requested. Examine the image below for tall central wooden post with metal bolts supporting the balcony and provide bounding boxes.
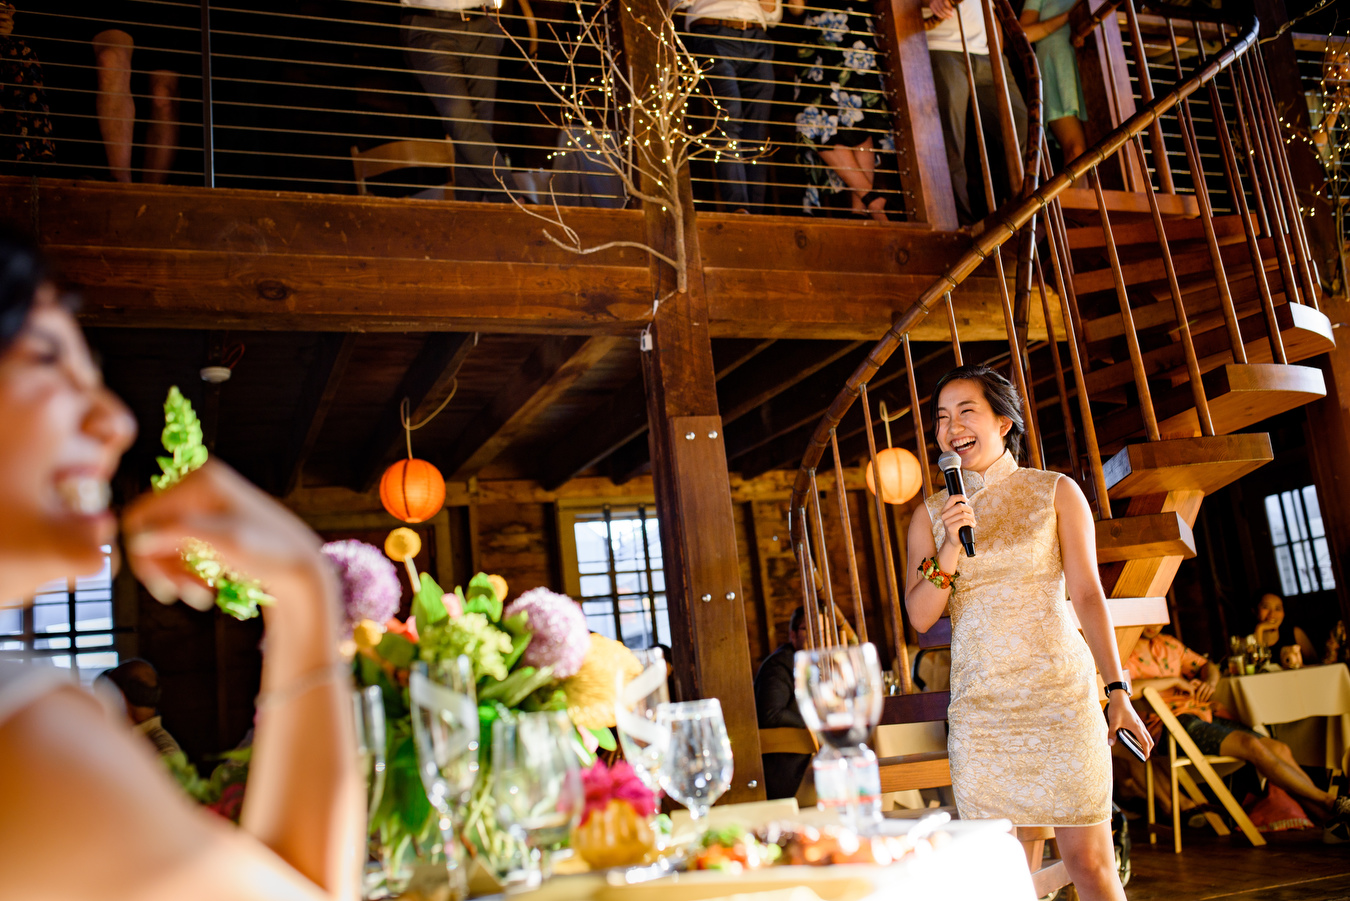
[620,0,764,802]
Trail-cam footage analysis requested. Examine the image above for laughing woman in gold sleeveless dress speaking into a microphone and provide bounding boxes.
[905,366,1153,901]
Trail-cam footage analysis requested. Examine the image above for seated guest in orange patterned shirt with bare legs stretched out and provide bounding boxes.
[1125,625,1350,842]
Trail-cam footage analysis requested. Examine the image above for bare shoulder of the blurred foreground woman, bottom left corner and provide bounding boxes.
[0,688,321,901]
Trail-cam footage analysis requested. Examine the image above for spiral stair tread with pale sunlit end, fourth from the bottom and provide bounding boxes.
[1098,363,1327,448]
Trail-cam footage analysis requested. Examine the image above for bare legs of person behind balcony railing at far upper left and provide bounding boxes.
[93,28,178,184]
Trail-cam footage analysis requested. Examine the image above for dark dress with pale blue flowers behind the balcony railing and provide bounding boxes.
[792,0,895,212]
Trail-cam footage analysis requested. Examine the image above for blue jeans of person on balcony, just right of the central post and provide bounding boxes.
[684,20,774,212]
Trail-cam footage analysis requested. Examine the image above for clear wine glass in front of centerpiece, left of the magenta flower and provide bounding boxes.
[493,711,586,885]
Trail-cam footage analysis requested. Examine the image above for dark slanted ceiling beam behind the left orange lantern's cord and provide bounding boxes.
[352,332,478,490]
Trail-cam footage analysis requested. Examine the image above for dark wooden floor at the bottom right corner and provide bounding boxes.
[1125,821,1350,901]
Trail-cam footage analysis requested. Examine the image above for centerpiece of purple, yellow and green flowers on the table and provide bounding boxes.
[348,573,641,874]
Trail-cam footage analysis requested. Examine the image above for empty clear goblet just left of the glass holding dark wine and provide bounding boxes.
[656,697,732,821]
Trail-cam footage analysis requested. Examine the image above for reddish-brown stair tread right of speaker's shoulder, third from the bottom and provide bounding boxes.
[1102,432,1274,500]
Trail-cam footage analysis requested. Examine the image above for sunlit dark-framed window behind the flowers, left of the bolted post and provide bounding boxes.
[568,504,671,650]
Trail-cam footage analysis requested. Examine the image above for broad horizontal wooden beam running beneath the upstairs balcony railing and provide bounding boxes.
[0,176,1062,340]
